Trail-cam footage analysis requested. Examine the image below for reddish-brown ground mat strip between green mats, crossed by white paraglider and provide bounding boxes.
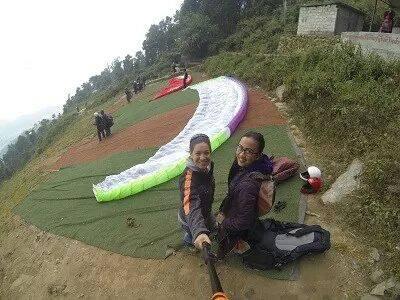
[51,91,285,170]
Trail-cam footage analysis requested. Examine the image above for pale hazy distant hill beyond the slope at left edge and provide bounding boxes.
[0,105,62,157]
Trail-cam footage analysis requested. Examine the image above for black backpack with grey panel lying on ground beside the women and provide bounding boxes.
[242,219,331,270]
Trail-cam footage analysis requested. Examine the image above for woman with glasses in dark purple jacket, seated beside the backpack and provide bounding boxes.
[217,131,272,258]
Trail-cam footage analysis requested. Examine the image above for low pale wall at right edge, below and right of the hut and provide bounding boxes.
[341,32,400,59]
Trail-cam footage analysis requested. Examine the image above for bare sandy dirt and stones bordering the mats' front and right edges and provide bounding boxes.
[0,85,397,299]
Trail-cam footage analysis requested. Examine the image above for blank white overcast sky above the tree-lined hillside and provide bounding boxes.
[0,0,183,123]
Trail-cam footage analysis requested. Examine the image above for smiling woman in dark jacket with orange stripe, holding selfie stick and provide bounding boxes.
[178,134,215,249]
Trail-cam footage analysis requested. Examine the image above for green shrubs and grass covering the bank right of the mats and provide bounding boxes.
[204,38,400,277]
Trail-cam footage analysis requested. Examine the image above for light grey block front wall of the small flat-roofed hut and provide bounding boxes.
[297,4,338,35]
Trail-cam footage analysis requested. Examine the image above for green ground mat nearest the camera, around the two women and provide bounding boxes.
[15,126,301,278]
